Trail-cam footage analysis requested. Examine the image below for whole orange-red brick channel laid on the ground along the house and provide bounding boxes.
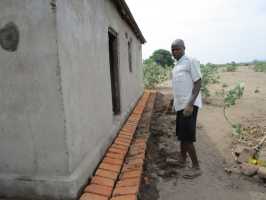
[79,90,156,200]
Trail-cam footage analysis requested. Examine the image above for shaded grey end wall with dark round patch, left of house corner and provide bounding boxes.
[0,0,69,196]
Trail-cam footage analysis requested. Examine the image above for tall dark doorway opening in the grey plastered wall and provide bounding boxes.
[108,28,121,115]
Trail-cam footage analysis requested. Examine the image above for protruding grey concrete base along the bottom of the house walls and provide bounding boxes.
[0,93,143,200]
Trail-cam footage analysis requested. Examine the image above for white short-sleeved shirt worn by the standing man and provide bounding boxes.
[172,55,202,111]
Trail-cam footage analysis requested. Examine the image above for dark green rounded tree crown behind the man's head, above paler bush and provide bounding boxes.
[150,49,174,68]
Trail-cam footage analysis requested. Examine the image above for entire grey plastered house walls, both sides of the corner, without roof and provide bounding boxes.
[0,0,143,199]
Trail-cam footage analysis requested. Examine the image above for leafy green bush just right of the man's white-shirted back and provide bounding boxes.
[200,63,220,97]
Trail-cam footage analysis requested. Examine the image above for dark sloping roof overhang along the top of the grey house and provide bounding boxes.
[111,0,146,44]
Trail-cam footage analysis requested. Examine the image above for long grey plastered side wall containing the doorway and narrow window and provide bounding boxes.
[57,0,143,177]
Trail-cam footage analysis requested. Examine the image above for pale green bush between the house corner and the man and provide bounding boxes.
[143,59,172,88]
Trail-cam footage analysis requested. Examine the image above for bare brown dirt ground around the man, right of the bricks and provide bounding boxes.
[140,67,266,200]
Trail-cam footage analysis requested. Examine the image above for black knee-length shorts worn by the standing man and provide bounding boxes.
[176,106,198,142]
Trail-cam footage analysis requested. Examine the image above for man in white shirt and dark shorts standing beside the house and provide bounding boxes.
[171,39,202,178]
